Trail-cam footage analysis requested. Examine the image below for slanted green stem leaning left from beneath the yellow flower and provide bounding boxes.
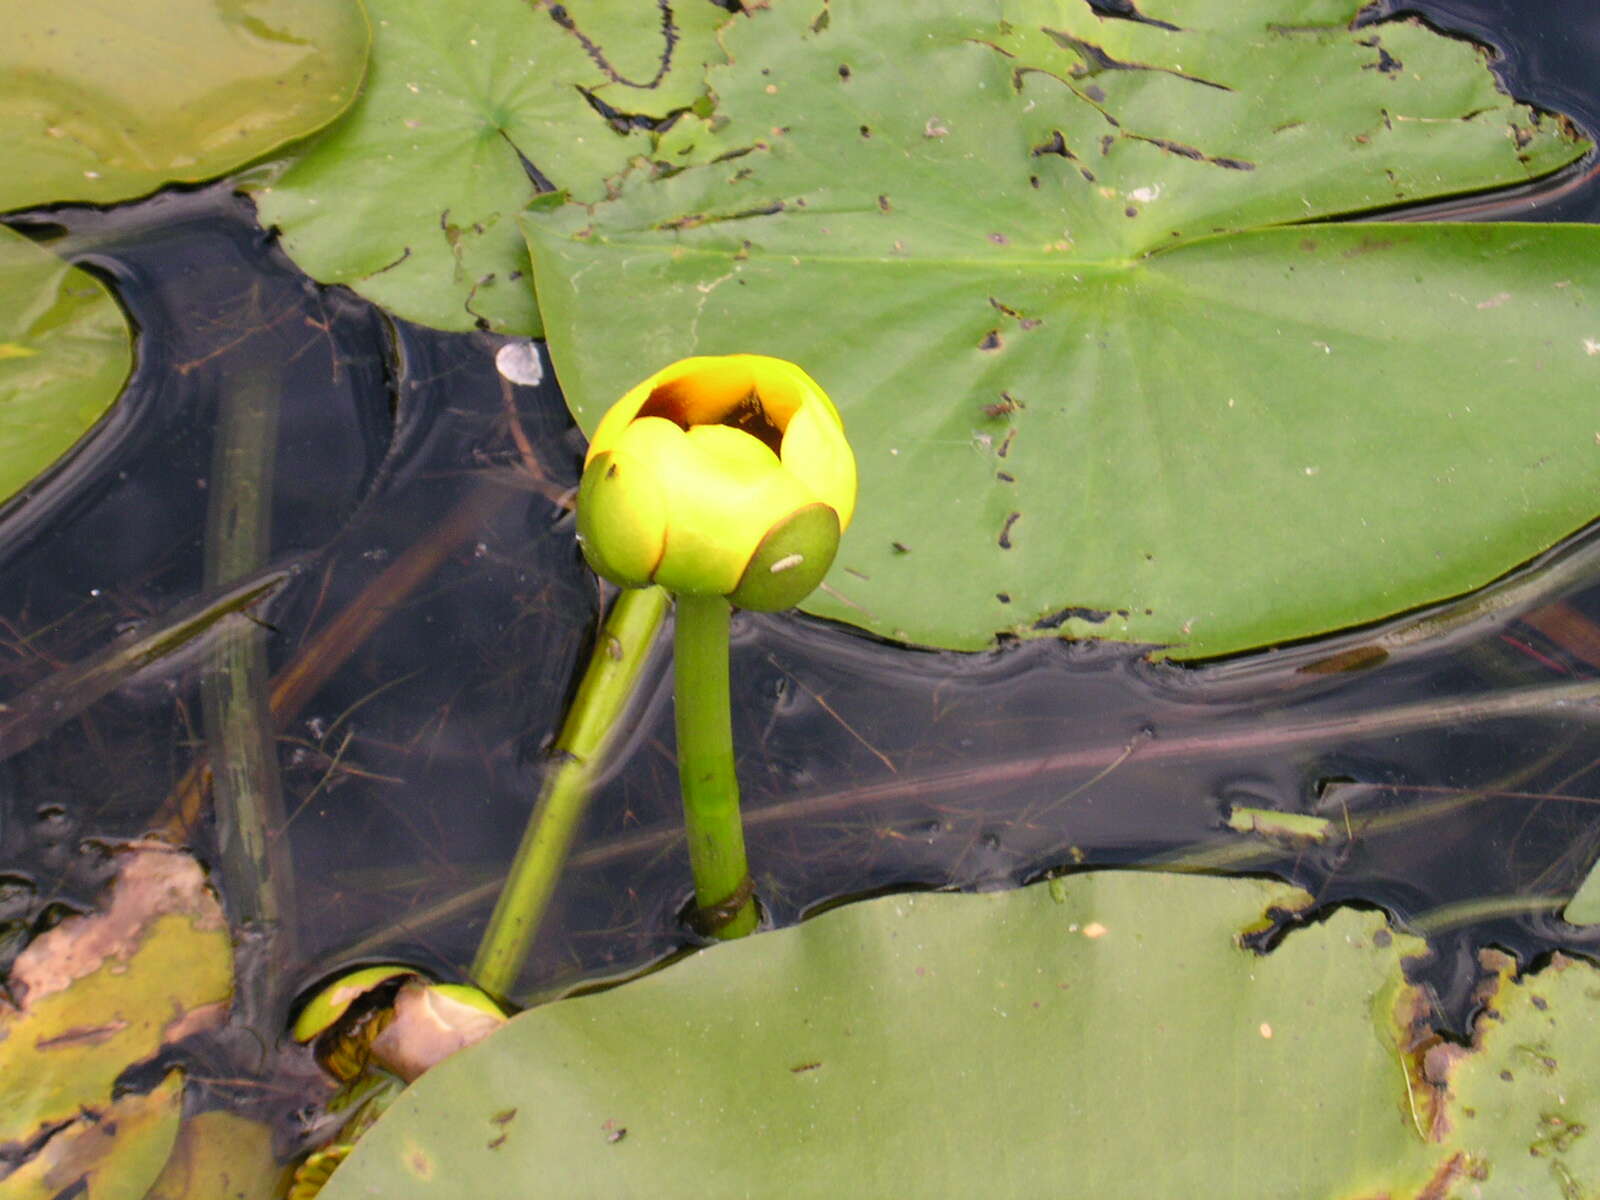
[472,587,667,998]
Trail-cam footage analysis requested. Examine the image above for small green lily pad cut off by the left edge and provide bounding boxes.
[0,226,133,499]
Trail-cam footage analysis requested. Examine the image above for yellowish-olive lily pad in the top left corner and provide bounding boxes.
[0,0,370,211]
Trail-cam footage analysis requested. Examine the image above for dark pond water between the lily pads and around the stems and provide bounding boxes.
[9,0,1600,1171]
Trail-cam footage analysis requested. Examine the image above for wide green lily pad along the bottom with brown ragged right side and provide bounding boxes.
[323,872,1600,1200]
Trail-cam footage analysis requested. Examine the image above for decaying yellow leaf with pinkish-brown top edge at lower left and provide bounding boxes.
[0,843,234,1145]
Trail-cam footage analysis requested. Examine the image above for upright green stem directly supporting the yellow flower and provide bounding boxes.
[672,595,757,938]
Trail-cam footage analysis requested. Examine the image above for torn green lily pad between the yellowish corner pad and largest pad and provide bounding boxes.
[256,0,728,334]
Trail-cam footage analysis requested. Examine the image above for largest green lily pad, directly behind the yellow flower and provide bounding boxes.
[526,0,1600,656]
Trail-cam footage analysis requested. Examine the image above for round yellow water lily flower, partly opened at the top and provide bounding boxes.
[578,354,856,611]
